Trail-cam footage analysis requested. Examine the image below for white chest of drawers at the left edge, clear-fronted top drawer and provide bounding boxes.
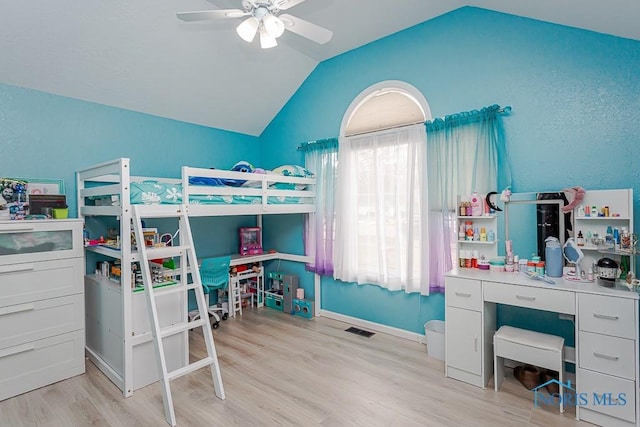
[0,219,85,400]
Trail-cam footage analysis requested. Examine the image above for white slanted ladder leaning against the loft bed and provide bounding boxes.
[133,205,225,426]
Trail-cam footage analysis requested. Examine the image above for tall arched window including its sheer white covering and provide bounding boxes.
[333,81,431,294]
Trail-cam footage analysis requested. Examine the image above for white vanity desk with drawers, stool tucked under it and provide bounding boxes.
[445,269,640,426]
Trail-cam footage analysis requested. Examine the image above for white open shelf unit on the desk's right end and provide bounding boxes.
[573,189,635,278]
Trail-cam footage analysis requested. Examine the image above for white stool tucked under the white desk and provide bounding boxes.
[493,326,564,413]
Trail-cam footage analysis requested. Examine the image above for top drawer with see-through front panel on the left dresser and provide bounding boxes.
[0,219,84,265]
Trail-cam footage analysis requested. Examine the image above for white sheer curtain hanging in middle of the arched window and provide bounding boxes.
[333,124,429,295]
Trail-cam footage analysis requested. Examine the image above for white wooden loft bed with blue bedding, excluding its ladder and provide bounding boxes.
[76,158,315,397]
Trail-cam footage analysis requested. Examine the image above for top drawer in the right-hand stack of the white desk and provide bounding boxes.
[578,294,638,339]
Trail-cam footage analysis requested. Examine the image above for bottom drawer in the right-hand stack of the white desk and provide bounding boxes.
[576,369,636,423]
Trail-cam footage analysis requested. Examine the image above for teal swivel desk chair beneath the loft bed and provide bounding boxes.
[189,256,231,329]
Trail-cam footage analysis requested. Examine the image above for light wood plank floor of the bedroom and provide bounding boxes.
[0,308,587,427]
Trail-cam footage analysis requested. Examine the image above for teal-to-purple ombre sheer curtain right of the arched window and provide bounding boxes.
[426,105,511,292]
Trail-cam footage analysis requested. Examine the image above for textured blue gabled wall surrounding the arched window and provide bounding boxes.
[261,7,640,332]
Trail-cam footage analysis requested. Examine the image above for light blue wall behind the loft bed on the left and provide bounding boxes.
[0,84,260,255]
